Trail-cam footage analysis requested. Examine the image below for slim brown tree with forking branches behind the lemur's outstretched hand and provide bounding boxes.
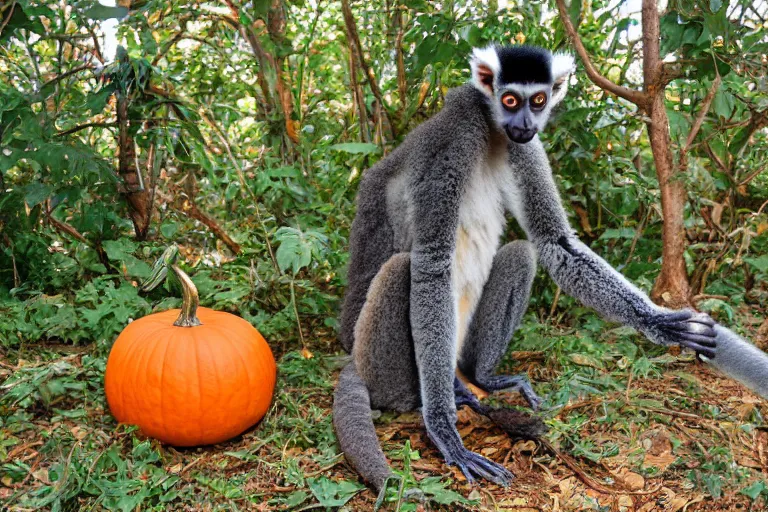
[556,0,764,307]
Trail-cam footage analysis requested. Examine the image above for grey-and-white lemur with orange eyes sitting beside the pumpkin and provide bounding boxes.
[333,46,768,499]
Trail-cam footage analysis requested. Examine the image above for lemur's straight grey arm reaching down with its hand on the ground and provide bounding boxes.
[409,133,512,485]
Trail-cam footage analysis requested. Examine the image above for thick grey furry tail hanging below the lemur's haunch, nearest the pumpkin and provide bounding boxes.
[333,361,392,491]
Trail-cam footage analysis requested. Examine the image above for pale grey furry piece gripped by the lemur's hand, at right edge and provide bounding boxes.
[702,325,768,398]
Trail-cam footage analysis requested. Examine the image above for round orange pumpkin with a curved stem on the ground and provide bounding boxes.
[105,248,277,446]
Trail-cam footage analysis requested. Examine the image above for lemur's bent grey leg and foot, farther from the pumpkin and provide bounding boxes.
[458,240,541,409]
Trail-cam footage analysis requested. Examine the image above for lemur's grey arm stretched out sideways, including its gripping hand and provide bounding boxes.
[510,140,715,357]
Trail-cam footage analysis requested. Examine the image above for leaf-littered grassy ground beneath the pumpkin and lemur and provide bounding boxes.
[0,315,768,512]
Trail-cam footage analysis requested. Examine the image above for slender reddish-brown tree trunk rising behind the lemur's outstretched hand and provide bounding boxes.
[642,0,691,307]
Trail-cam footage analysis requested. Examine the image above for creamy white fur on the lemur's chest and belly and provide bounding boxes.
[452,152,512,354]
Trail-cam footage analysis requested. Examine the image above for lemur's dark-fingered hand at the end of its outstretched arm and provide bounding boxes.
[640,309,716,359]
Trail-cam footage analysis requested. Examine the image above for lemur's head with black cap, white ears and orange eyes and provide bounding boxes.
[470,46,574,144]
